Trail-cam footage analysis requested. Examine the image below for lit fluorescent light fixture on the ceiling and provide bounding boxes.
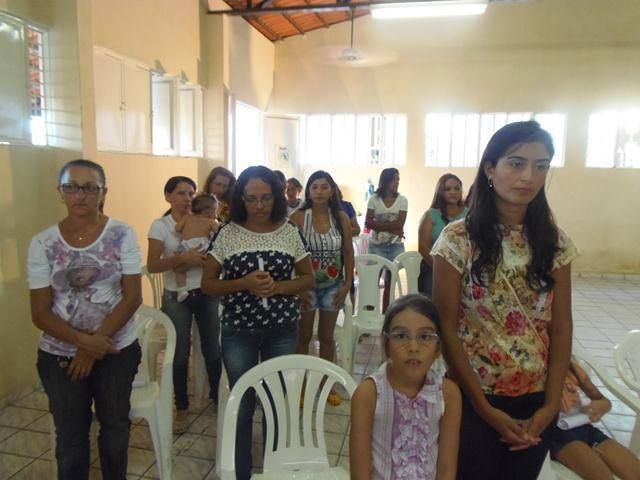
[370,0,488,19]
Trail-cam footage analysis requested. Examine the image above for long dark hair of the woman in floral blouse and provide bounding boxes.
[465,121,559,292]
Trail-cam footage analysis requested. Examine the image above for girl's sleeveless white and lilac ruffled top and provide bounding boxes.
[367,362,444,480]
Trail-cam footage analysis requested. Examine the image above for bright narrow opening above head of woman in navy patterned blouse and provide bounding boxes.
[233,101,264,175]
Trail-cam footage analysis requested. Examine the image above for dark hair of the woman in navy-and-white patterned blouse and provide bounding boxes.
[230,165,287,223]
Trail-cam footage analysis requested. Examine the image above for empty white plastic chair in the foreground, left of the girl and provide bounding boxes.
[218,355,357,480]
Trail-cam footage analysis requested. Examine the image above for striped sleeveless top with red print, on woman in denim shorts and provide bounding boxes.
[302,208,342,288]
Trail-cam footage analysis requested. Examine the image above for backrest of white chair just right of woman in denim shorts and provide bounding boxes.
[355,253,398,316]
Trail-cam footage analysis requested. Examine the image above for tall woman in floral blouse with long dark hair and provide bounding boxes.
[431,121,577,479]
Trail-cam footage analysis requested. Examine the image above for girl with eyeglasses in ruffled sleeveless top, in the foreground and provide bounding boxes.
[349,294,461,480]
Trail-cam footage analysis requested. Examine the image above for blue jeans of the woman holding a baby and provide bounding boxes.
[162,288,222,410]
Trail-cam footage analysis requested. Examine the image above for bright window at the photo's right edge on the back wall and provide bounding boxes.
[587,110,640,168]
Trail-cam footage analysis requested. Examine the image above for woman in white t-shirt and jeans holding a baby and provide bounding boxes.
[147,176,222,433]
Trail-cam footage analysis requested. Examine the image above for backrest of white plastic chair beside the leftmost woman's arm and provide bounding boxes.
[133,305,176,391]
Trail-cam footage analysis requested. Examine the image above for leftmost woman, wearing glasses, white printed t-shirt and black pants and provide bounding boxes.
[27,159,142,480]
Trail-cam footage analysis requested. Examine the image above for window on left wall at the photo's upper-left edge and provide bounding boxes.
[0,13,47,145]
